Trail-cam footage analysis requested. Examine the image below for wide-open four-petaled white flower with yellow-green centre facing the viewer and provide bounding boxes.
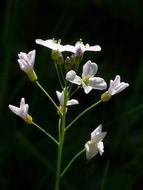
[66,61,107,94]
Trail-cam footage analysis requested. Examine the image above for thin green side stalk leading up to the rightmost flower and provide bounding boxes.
[65,100,102,131]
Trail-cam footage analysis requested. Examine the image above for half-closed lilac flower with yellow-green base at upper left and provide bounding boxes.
[18,50,37,81]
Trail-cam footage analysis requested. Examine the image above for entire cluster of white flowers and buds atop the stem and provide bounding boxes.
[9,39,129,165]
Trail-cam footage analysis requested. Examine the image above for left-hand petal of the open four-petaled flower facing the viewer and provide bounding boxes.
[66,70,81,85]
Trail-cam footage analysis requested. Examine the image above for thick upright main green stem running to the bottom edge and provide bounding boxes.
[55,88,67,190]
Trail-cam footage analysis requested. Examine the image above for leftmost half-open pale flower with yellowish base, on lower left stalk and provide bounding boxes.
[8,98,32,124]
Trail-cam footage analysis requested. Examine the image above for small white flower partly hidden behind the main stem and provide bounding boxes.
[56,91,79,108]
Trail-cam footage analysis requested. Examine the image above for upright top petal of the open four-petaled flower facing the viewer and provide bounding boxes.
[82,60,98,77]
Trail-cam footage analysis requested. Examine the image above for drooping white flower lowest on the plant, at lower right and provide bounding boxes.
[85,124,107,159]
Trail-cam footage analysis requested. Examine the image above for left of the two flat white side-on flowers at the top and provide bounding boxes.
[36,39,65,52]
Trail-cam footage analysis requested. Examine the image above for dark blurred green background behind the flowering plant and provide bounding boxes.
[0,0,143,190]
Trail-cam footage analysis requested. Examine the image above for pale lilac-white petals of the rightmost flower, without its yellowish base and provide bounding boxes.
[108,75,129,96]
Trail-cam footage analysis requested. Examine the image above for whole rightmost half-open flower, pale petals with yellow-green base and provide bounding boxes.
[101,75,129,102]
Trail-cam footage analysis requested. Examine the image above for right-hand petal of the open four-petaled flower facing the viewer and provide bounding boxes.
[88,77,107,90]
